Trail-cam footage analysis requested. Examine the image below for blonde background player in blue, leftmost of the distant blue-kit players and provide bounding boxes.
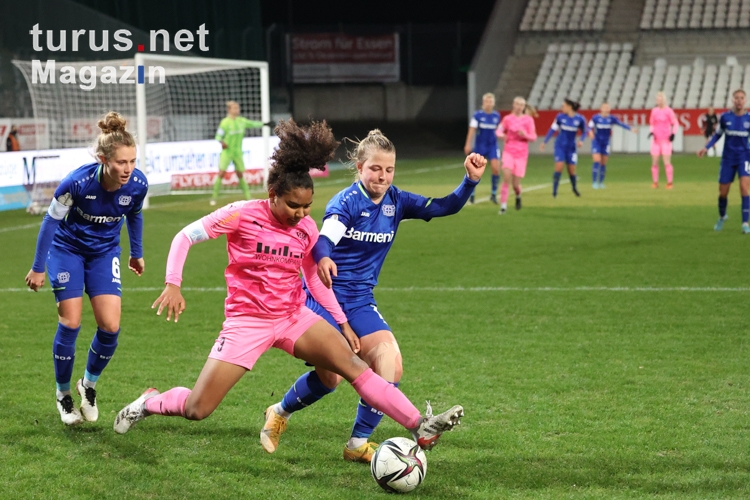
[464,92,500,205]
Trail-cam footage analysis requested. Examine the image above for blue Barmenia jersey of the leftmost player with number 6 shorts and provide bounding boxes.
[52,163,148,258]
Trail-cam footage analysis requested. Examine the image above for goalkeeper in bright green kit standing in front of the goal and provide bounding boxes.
[211,101,271,206]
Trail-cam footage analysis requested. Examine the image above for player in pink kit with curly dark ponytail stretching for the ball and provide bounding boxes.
[114,120,463,449]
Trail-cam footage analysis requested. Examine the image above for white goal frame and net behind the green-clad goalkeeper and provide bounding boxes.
[13,53,271,201]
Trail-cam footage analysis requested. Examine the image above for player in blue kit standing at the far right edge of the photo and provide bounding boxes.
[698,89,750,234]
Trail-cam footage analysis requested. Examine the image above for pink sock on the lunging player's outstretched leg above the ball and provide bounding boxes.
[352,368,421,429]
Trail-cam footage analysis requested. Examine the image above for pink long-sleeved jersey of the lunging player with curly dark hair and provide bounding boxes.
[166,199,346,323]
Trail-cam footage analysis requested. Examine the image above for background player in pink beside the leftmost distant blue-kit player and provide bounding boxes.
[497,97,536,215]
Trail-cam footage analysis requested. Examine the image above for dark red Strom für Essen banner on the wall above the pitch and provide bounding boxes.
[287,33,401,83]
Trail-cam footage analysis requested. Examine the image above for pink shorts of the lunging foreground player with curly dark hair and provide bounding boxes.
[208,306,325,370]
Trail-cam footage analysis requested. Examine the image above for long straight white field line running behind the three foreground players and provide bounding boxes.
[0,286,750,293]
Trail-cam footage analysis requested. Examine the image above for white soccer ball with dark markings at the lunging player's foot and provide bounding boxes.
[370,437,427,493]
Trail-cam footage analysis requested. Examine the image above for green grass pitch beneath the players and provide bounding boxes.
[0,155,750,499]
